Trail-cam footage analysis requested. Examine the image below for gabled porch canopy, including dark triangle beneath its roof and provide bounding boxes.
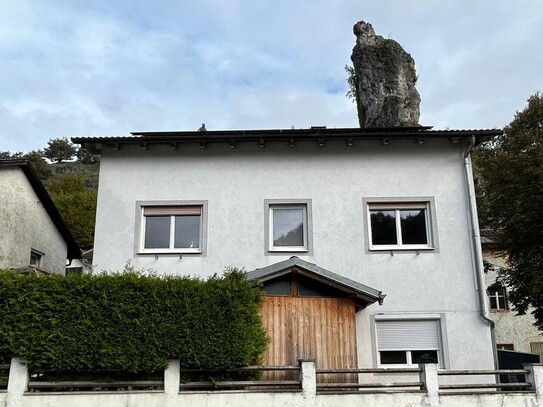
[246,256,385,311]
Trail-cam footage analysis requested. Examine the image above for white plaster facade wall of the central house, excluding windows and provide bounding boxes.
[93,140,493,368]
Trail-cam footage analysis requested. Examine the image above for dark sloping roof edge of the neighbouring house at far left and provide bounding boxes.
[0,159,81,259]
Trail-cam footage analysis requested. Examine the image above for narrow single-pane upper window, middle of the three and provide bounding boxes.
[265,200,311,252]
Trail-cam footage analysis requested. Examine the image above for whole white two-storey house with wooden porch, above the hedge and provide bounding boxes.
[72,127,501,380]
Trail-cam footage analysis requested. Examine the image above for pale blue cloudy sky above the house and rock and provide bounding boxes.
[0,0,543,151]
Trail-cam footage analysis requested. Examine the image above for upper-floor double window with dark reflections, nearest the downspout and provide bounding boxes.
[366,201,435,250]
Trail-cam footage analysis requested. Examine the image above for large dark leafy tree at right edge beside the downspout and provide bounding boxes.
[474,93,543,331]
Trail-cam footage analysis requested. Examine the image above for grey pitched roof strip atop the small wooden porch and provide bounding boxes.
[246,256,386,307]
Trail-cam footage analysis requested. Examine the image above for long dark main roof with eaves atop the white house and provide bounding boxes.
[72,126,503,153]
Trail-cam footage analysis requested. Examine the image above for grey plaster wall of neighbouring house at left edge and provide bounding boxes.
[0,168,67,274]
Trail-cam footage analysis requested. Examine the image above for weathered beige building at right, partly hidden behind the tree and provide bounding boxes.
[481,229,543,361]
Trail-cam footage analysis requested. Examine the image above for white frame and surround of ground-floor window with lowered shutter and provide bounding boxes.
[373,314,446,369]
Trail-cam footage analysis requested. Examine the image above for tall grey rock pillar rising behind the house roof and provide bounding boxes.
[351,21,420,127]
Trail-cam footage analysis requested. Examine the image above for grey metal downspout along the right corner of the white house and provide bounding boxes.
[464,136,498,369]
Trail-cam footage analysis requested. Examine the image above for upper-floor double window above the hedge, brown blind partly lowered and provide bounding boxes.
[138,203,205,254]
